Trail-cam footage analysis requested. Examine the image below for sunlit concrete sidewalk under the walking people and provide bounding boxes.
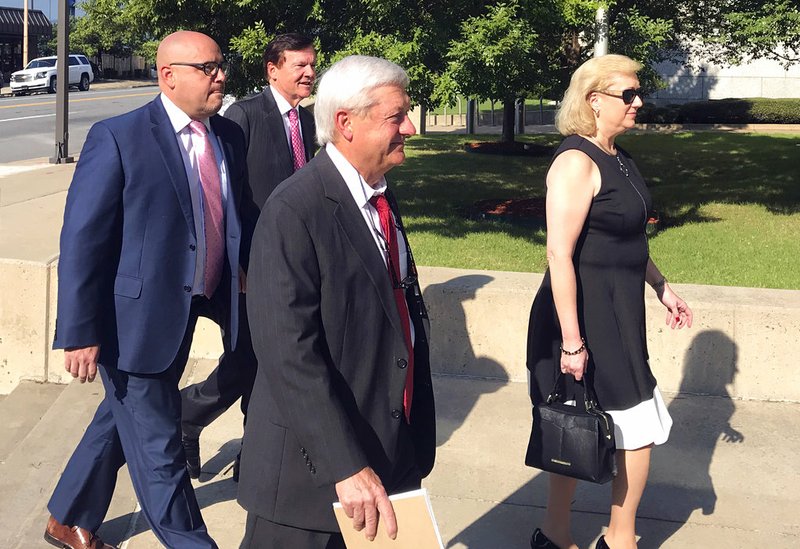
[0,360,800,549]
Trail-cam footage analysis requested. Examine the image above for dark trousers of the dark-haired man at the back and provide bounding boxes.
[181,294,257,438]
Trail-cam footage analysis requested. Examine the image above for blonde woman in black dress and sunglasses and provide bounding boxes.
[527,55,692,549]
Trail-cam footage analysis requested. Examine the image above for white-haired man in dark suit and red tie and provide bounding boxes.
[238,56,435,549]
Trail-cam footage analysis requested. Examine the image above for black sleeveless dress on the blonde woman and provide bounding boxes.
[527,135,660,410]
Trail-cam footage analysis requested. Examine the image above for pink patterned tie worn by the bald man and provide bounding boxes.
[189,120,225,297]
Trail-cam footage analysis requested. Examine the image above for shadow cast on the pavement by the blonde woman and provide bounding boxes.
[447,330,744,549]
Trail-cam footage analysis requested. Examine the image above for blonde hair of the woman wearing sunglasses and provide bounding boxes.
[556,54,642,135]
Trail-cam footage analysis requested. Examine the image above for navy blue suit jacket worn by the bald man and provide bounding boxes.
[53,98,257,374]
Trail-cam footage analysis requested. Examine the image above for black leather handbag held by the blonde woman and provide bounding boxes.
[525,373,617,484]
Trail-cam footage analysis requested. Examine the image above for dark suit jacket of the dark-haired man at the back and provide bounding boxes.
[225,86,316,208]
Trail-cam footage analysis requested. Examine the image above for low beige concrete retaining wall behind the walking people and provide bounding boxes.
[0,260,800,402]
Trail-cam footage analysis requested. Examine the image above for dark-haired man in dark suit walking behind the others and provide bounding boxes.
[181,33,317,480]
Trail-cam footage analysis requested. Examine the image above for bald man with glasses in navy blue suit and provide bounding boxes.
[45,31,255,549]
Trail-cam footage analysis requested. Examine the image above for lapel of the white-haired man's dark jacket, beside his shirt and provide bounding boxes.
[316,149,403,335]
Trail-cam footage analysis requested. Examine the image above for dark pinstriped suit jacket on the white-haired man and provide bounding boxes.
[239,151,435,531]
